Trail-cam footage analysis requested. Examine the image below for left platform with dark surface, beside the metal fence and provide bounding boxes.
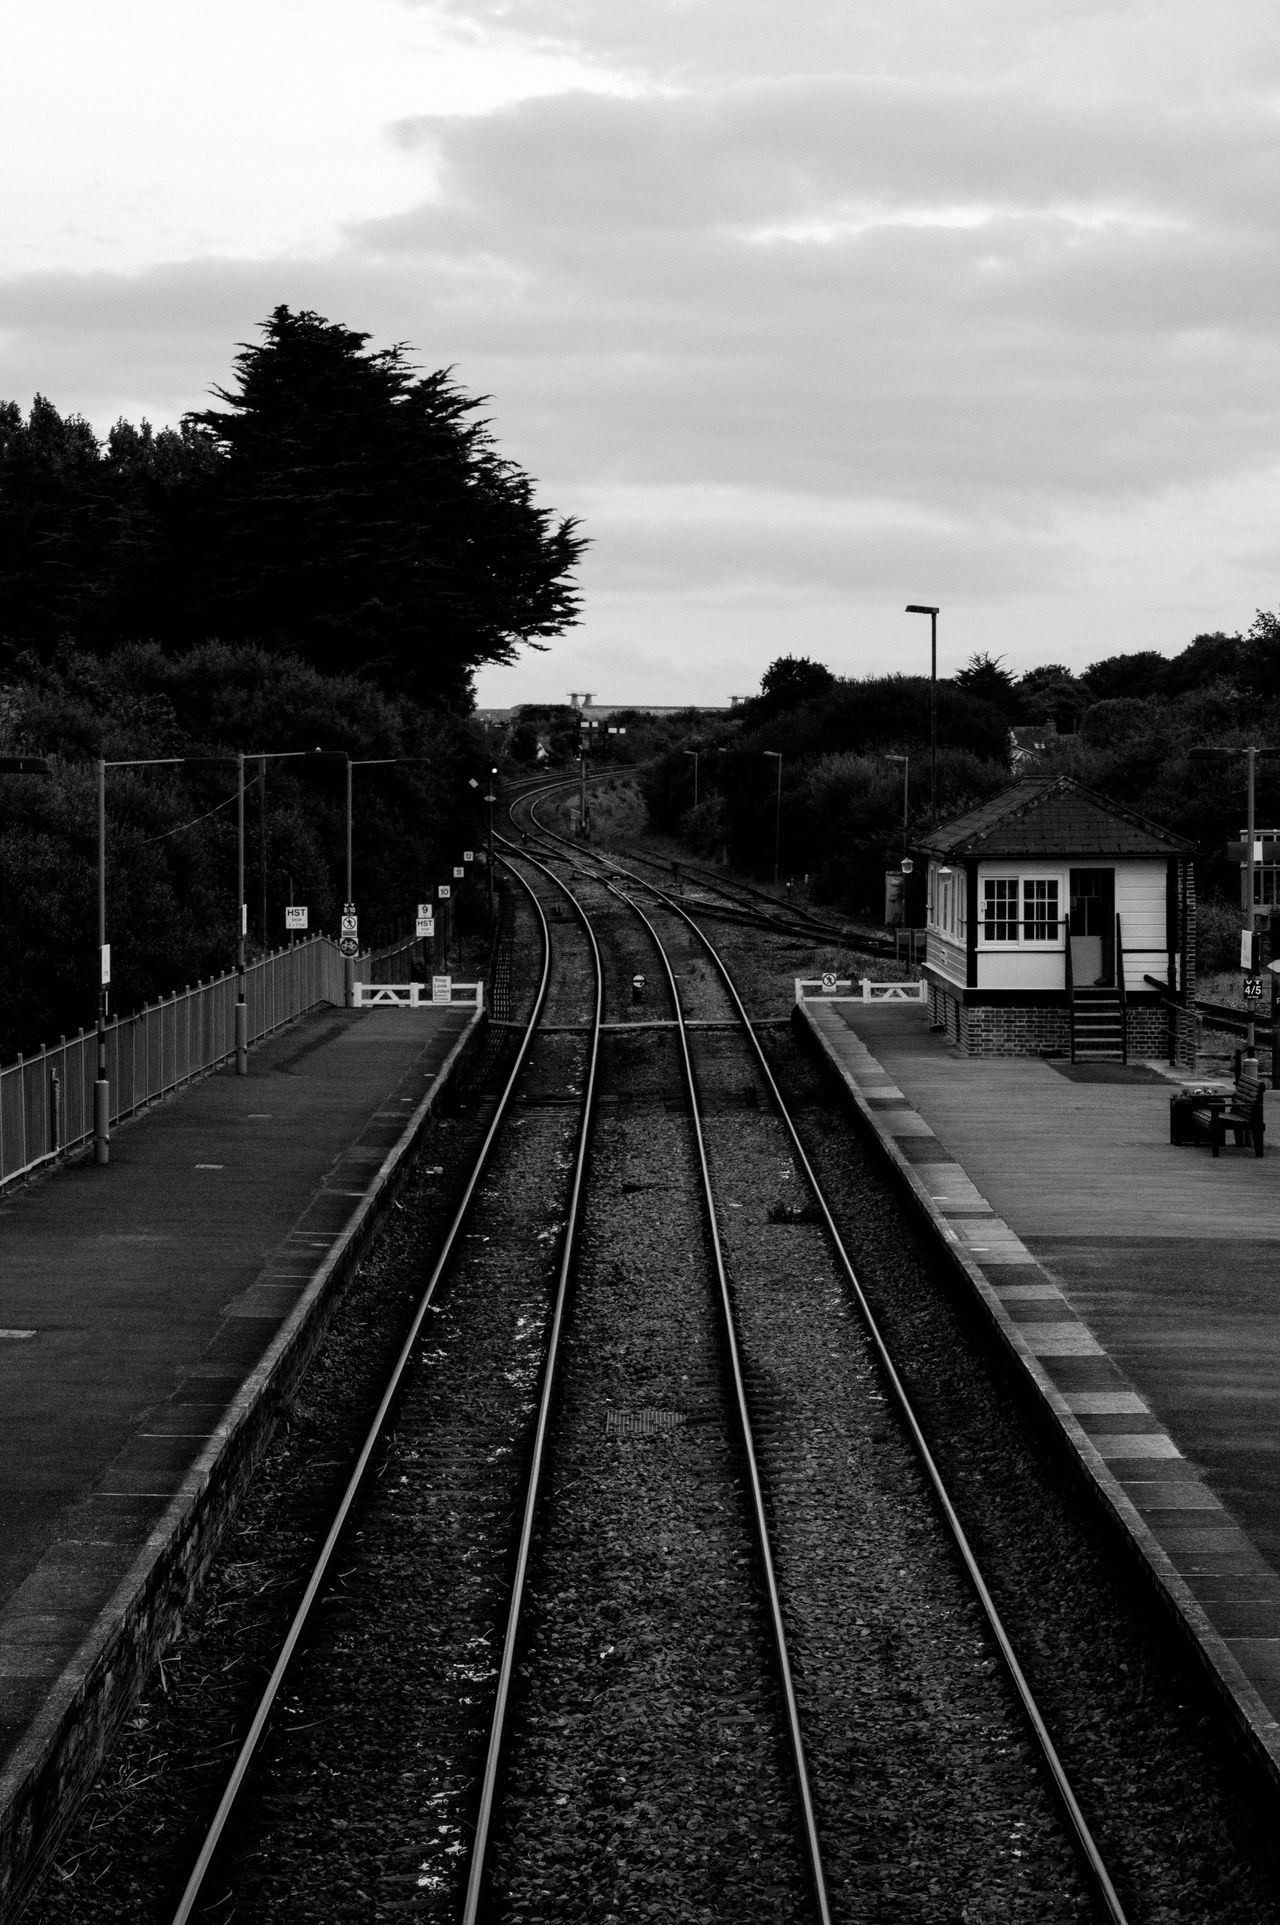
[0,1001,481,1917]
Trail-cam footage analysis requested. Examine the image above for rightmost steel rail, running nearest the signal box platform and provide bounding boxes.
[650,881,1128,1925]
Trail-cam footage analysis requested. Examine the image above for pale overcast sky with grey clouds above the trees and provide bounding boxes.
[0,0,1280,705]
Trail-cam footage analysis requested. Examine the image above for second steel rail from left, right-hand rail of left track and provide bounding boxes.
[462,857,604,1925]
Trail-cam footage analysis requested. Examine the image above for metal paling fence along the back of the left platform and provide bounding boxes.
[0,936,429,1190]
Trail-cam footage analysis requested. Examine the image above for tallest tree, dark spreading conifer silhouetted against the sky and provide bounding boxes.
[189,306,583,706]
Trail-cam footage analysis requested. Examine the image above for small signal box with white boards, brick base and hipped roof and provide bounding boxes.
[916,776,1195,1066]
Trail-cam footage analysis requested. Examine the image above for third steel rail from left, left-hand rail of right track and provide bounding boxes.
[606,884,832,1925]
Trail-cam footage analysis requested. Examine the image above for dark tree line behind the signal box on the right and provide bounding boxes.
[645,631,1280,926]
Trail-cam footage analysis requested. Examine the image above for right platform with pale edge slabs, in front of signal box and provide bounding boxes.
[797,986,1280,1784]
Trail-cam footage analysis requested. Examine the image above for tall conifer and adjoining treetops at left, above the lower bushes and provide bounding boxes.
[0,306,583,710]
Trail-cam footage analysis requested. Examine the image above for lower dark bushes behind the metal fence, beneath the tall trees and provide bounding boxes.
[0,643,487,1063]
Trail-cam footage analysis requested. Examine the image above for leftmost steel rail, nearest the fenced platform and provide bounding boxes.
[173,876,550,1925]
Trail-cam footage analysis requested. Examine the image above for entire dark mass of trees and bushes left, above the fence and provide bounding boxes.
[0,308,583,1061]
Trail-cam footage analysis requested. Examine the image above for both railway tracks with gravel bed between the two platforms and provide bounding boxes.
[25,789,1261,1925]
